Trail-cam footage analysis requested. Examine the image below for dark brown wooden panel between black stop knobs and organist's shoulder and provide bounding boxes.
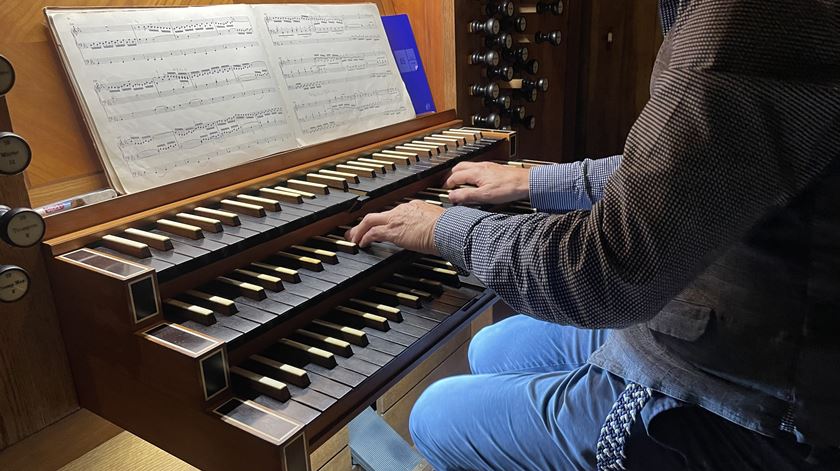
[575,0,662,158]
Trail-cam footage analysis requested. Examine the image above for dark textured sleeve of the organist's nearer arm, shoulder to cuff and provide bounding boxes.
[436,0,840,328]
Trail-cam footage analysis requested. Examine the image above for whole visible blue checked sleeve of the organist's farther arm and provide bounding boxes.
[529,155,621,213]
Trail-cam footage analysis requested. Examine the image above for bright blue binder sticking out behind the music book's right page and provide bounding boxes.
[382,15,436,115]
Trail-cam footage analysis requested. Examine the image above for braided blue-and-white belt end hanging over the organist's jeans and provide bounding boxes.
[595,383,653,471]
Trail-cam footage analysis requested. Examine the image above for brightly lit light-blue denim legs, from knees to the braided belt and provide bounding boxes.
[410,316,624,470]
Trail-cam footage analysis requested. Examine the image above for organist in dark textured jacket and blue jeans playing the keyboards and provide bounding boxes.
[348,0,840,470]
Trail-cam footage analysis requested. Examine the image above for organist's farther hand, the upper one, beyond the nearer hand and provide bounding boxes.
[443,162,529,204]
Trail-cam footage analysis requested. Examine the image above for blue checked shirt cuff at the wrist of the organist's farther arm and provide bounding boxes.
[528,162,588,213]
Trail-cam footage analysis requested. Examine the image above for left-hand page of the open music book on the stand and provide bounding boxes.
[48,5,297,193]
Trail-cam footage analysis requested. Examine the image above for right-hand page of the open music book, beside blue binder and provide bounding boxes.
[254,4,415,145]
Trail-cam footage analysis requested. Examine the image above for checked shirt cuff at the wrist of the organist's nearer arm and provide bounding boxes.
[435,206,493,274]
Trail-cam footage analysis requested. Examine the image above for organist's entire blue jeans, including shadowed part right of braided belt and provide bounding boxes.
[409,315,840,471]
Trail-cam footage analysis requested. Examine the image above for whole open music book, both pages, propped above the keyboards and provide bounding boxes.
[45,4,415,193]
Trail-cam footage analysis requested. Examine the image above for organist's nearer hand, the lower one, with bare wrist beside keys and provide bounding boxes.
[344,200,444,255]
